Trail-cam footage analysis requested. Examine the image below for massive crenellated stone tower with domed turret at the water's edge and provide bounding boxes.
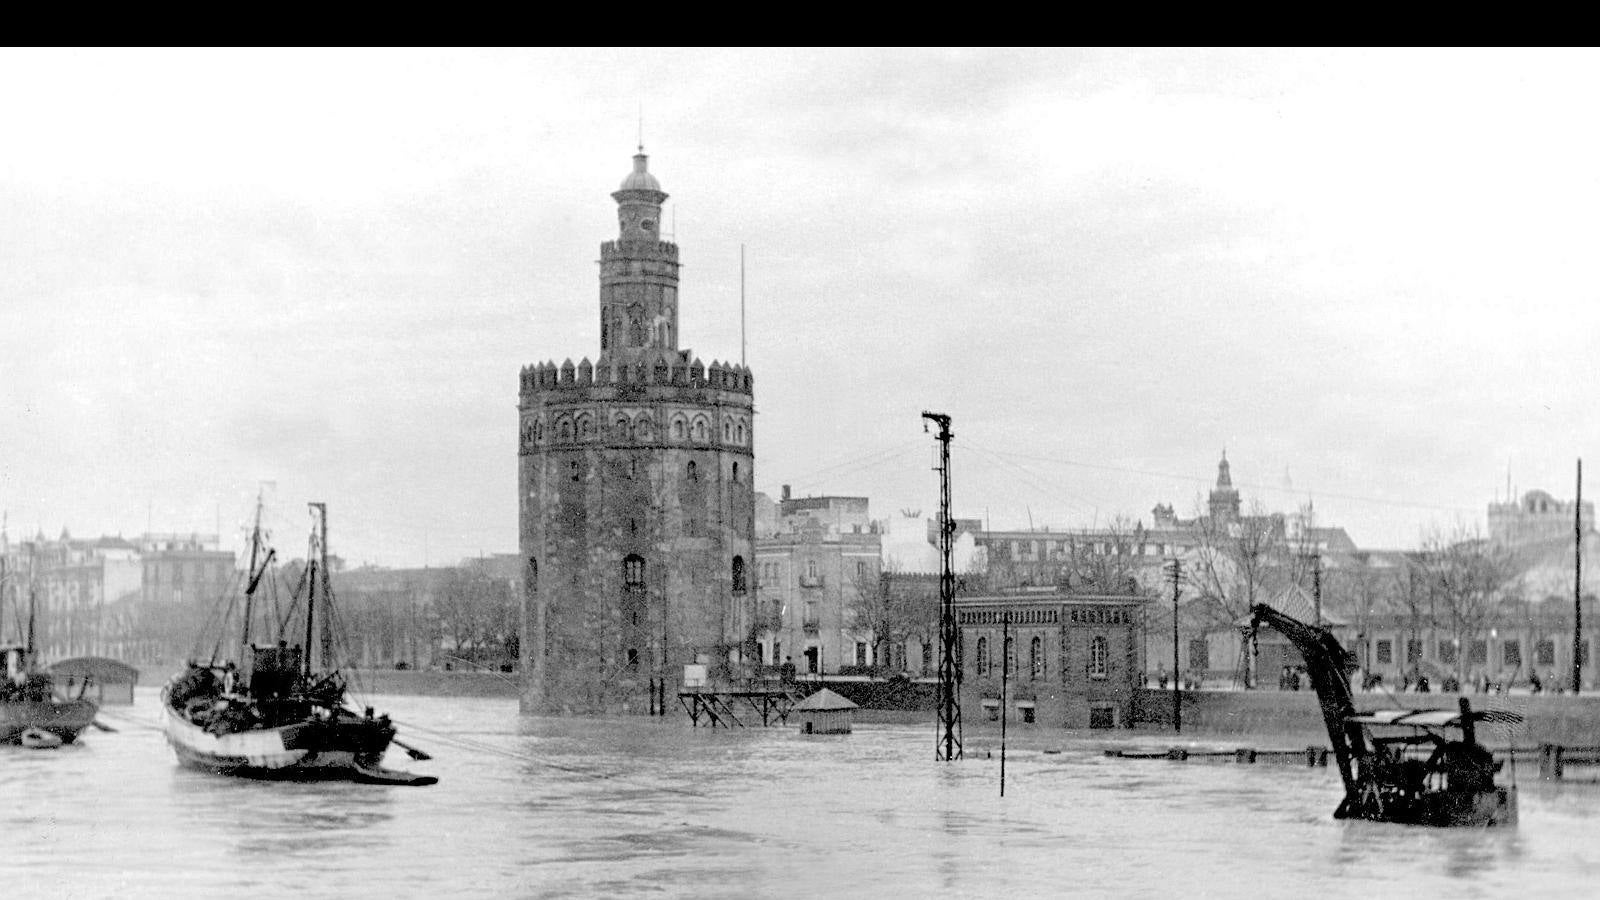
[518,147,755,713]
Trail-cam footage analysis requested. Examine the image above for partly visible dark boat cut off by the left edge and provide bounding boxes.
[0,556,99,748]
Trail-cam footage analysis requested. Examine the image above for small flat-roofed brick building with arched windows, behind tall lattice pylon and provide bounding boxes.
[955,588,1147,729]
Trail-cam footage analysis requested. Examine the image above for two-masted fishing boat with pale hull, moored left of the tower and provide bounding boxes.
[162,500,438,785]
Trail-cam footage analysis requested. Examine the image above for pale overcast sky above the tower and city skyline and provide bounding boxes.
[0,50,1600,565]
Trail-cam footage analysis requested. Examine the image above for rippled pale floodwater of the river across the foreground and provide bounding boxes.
[0,689,1600,898]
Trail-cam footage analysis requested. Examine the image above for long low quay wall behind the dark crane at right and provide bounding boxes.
[1134,689,1600,746]
